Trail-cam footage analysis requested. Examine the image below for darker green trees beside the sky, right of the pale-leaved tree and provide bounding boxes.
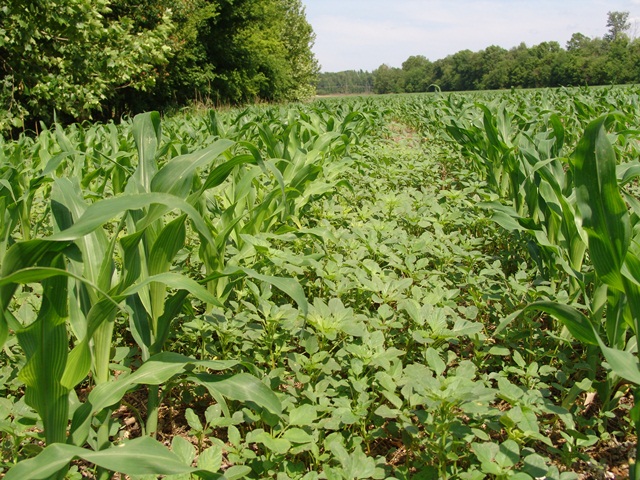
[104,0,318,110]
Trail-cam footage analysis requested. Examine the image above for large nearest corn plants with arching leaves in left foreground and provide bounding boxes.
[0,113,306,479]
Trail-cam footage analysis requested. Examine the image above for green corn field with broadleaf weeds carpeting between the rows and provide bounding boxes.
[0,87,640,480]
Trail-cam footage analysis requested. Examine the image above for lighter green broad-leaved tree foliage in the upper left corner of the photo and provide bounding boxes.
[0,0,172,132]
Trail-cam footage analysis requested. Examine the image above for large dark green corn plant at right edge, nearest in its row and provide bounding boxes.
[527,115,640,480]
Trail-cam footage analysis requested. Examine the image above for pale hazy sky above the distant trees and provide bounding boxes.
[302,0,640,72]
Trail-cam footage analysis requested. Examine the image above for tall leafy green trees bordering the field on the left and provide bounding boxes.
[0,0,319,133]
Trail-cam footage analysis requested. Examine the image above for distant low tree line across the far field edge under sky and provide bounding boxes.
[318,12,640,94]
